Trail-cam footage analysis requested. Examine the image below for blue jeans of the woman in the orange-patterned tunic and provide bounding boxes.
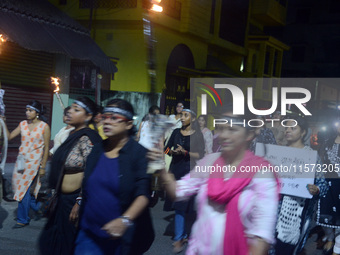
[17,187,41,224]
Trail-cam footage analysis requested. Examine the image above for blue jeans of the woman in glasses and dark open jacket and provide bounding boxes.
[74,229,120,255]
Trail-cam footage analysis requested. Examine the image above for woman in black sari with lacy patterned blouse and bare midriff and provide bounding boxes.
[39,97,102,255]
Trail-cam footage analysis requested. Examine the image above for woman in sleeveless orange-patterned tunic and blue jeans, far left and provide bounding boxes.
[1,100,51,228]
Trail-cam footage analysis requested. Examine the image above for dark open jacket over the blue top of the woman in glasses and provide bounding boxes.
[80,138,154,254]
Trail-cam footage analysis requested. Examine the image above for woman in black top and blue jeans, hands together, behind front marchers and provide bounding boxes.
[164,109,204,253]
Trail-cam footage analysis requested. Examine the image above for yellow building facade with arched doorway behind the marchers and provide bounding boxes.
[50,0,288,116]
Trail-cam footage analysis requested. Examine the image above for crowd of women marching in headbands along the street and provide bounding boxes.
[1,97,340,255]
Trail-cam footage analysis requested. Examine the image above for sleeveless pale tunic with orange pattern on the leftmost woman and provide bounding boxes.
[12,120,47,202]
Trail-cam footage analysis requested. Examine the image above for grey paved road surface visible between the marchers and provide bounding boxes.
[0,164,322,255]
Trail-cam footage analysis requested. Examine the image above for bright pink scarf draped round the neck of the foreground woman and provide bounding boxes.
[208,151,276,255]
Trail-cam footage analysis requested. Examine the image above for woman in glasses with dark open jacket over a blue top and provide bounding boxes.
[75,99,154,255]
